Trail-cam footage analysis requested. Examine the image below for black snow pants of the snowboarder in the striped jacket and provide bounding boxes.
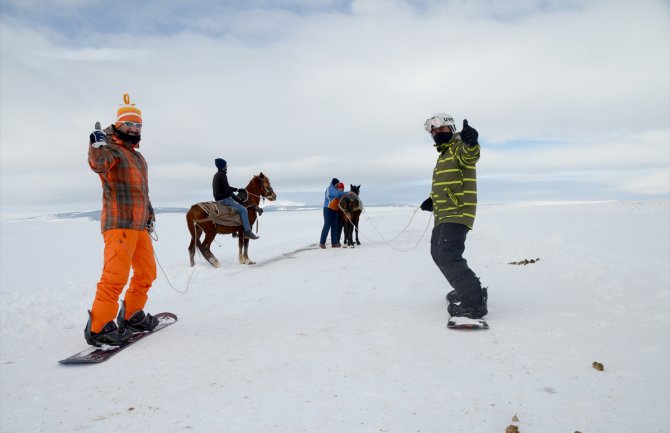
[430,223,482,307]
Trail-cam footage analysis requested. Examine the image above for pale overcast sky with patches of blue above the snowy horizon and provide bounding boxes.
[0,0,670,212]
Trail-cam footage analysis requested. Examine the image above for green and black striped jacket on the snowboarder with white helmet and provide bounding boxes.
[430,134,480,229]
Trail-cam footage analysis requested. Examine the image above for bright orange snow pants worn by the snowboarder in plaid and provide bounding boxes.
[91,229,156,332]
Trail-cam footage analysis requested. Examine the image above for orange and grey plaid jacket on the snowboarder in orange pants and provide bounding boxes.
[88,126,155,233]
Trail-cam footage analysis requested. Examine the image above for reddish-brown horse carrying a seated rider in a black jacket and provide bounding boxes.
[186,173,277,267]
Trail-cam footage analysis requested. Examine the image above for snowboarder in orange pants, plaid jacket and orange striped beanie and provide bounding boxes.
[84,94,158,346]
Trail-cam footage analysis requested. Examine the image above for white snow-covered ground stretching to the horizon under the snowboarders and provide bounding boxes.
[0,201,670,433]
